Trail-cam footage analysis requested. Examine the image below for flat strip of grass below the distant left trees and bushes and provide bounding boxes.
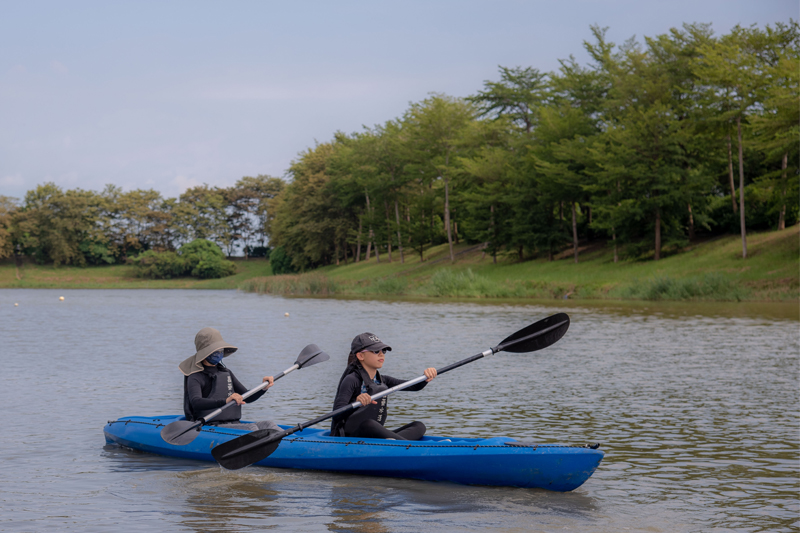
[0,259,272,289]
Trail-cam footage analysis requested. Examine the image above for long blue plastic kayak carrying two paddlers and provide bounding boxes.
[103,416,604,492]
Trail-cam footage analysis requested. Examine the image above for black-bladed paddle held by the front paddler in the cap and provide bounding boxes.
[211,313,569,470]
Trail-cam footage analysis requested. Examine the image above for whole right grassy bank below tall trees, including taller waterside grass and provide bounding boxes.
[240,226,800,302]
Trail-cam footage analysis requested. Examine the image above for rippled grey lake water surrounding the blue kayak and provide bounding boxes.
[0,290,800,533]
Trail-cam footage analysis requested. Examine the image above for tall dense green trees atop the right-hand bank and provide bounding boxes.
[270,22,800,270]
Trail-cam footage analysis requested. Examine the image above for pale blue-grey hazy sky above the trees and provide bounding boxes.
[0,0,800,199]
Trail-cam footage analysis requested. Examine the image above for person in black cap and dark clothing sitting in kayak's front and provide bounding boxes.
[331,333,436,440]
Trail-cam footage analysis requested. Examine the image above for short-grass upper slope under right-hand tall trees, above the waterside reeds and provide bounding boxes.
[318,226,800,300]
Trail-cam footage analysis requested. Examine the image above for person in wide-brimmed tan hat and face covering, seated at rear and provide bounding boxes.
[178,328,280,431]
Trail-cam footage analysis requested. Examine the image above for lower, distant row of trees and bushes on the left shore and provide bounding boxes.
[0,175,285,264]
